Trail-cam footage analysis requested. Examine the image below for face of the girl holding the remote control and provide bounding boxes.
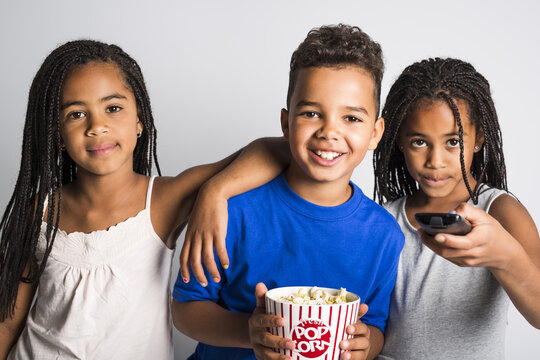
[399,100,483,201]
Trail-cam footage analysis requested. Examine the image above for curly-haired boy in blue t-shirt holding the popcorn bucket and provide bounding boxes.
[172,25,404,359]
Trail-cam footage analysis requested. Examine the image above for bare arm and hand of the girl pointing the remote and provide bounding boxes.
[422,200,540,329]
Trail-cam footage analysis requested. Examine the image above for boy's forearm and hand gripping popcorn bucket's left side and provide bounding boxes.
[172,283,294,360]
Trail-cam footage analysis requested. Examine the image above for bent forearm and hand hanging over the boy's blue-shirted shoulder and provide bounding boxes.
[180,137,290,286]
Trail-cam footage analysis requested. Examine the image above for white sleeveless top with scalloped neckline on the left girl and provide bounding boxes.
[8,177,174,360]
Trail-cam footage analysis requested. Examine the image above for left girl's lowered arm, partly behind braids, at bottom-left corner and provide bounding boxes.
[0,265,36,359]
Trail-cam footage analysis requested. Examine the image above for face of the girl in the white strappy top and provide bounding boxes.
[60,62,142,179]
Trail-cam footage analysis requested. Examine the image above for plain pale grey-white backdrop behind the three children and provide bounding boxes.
[0,0,540,359]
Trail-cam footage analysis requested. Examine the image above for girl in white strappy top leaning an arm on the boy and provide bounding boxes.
[0,40,281,359]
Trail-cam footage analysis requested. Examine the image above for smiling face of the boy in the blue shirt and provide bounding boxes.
[281,66,384,198]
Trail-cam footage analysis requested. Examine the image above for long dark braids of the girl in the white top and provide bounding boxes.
[0,40,161,322]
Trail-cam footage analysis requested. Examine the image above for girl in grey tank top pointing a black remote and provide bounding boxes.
[373,58,540,360]
